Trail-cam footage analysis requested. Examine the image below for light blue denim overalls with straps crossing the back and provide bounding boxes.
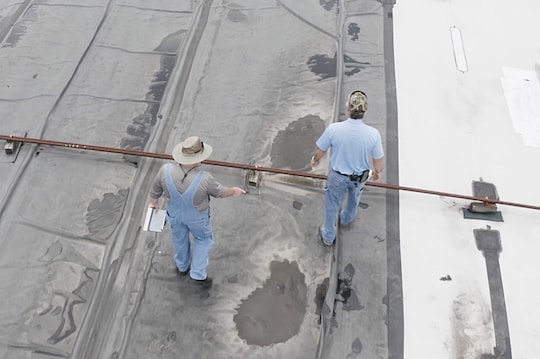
[165,164,214,280]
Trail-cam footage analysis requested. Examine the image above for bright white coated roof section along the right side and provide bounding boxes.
[394,0,540,358]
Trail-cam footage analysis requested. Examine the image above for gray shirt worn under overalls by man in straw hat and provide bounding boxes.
[150,163,227,211]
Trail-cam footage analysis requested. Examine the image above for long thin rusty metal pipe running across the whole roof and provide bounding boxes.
[0,134,540,210]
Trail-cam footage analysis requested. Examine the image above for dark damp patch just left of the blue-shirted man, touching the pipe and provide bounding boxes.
[270,115,324,171]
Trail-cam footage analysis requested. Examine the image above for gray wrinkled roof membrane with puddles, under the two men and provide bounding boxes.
[0,0,403,358]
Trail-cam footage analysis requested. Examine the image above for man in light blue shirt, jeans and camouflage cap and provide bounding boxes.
[311,91,384,246]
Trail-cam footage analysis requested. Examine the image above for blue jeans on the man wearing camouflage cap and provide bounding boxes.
[321,170,365,243]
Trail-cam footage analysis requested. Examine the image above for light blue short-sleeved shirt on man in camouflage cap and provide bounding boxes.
[316,118,384,174]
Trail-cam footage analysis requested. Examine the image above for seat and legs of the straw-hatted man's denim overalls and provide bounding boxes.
[170,215,214,280]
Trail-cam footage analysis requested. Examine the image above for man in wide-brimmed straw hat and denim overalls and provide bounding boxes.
[150,136,245,285]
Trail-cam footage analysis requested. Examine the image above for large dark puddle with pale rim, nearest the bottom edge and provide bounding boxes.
[233,260,307,346]
